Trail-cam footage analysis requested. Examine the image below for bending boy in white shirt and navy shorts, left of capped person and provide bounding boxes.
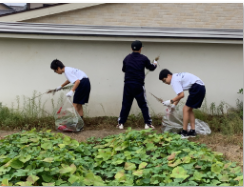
[51,59,91,119]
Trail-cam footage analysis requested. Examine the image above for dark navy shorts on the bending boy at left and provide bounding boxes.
[73,78,91,105]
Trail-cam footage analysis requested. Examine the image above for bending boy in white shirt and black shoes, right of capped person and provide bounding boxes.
[159,69,206,138]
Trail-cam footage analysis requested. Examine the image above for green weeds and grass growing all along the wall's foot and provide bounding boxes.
[0,91,243,135]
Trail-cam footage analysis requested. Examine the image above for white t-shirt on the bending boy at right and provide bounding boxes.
[170,72,204,95]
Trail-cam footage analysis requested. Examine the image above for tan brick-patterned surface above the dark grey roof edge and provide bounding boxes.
[23,3,243,29]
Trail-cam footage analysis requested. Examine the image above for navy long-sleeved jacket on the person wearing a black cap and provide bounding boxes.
[122,52,157,85]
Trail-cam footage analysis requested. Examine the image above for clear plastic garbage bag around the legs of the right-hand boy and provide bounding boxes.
[162,107,211,135]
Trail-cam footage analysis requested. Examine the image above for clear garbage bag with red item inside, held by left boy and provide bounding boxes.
[54,98,84,132]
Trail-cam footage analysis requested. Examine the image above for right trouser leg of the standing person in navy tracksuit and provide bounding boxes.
[135,85,152,125]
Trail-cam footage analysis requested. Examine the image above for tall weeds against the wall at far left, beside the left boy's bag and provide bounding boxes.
[0,91,63,130]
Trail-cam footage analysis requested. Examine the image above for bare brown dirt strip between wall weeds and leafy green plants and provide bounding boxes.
[0,126,243,167]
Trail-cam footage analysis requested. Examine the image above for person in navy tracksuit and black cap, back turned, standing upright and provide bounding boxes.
[117,40,157,129]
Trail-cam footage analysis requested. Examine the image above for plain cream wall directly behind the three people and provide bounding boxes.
[0,39,243,116]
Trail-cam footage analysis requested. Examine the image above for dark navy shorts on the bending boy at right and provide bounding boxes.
[186,83,206,108]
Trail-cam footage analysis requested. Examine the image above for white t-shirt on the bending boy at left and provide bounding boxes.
[64,67,88,83]
